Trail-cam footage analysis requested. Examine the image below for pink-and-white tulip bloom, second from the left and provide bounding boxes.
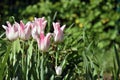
[19,21,31,40]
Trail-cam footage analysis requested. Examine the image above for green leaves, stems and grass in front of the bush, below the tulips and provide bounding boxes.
[0,25,119,80]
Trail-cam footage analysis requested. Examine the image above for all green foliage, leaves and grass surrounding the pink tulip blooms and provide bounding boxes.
[0,0,120,80]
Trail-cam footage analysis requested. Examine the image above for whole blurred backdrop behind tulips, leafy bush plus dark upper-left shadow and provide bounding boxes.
[0,0,120,48]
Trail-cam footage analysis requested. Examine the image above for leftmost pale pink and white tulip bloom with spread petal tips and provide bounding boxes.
[2,21,19,41]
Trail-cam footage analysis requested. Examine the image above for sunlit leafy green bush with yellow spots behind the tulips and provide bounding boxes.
[22,0,120,48]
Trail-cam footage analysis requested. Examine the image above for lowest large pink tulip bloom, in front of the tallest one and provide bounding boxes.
[37,32,51,52]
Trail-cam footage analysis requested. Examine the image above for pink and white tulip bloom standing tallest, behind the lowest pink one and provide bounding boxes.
[32,17,47,39]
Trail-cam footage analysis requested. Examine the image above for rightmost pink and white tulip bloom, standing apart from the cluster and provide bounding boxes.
[53,22,65,42]
